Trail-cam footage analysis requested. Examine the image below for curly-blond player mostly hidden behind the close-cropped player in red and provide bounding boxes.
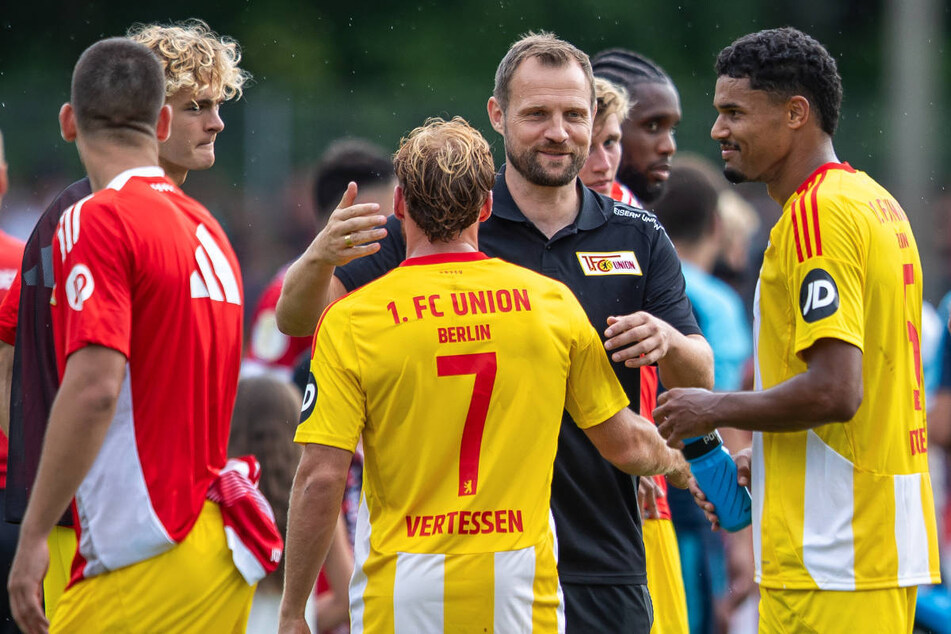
[0,20,249,618]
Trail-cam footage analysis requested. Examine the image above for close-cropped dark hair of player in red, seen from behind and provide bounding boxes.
[69,37,165,135]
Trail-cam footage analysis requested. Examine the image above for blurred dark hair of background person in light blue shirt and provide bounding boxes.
[654,163,720,244]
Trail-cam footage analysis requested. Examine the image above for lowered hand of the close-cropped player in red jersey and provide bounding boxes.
[7,536,50,634]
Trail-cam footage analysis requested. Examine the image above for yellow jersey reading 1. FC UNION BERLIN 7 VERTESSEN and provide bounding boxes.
[296,254,628,632]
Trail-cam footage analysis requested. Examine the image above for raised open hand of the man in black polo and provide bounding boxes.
[307,183,386,266]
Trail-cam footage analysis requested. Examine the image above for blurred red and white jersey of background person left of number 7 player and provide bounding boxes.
[242,266,314,380]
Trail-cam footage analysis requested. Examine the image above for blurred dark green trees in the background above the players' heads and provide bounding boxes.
[0,0,951,294]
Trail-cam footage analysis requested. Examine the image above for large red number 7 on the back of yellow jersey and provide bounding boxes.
[436,352,496,495]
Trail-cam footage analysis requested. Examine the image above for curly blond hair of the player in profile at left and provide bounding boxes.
[126,18,251,101]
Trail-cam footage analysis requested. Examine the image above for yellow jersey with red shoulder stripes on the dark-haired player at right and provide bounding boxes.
[752,163,939,590]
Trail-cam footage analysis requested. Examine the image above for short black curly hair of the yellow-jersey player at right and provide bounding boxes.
[716,26,842,136]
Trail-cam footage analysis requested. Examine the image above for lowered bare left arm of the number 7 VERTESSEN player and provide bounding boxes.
[281,445,349,619]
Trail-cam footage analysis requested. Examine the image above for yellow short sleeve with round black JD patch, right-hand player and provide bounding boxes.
[787,198,868,355]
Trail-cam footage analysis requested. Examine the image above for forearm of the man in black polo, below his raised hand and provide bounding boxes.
[276,254,334,337]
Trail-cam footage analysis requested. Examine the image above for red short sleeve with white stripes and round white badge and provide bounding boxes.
[51,197,133,359]
